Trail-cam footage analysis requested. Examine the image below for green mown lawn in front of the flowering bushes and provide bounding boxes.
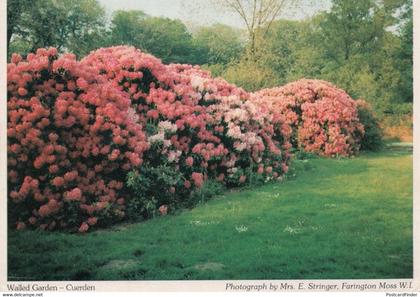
[8,152,413,280]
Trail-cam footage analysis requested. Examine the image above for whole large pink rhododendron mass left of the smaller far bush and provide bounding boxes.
[8,46,292,232]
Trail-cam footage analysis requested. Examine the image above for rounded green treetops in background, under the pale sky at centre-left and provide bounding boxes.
[109,14,243,65]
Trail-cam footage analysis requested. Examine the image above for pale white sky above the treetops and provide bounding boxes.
[99,0,330,28]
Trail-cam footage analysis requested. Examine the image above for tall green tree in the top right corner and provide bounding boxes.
[308,0,412,114]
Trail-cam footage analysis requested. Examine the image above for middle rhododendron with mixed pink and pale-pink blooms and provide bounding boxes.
[82,47,290,204]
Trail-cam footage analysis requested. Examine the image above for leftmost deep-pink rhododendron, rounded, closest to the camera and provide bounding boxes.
[7,49,149,232]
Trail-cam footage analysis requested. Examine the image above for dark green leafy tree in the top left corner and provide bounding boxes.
[8,0,105,55]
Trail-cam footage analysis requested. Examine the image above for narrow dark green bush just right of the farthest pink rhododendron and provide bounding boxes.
[356,100,383,151]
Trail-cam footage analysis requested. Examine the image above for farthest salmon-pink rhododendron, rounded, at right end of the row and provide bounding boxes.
[252,79,364,156]
